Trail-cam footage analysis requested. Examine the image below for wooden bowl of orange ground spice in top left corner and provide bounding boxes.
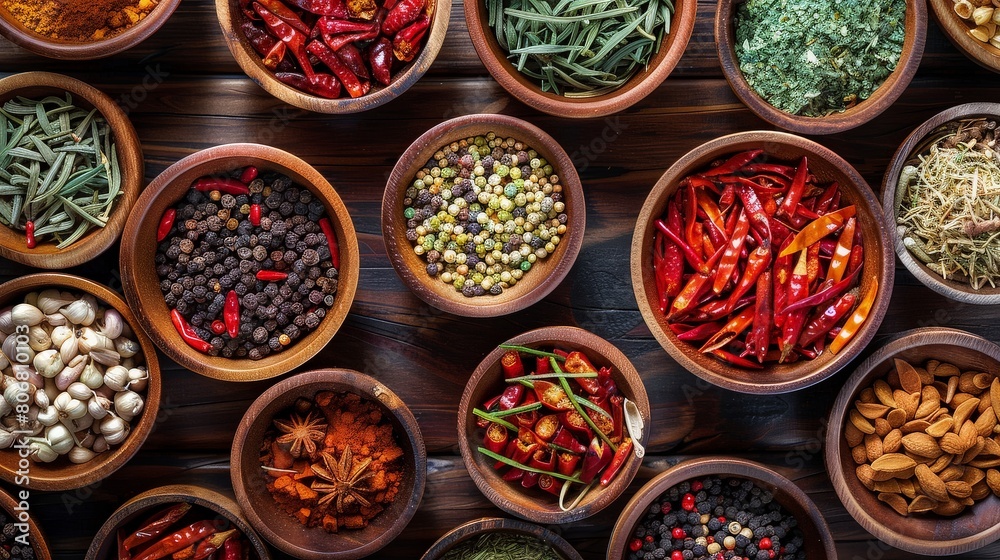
[0,0,181,60]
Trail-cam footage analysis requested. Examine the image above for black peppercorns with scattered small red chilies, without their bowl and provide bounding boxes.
[155,167,340,360]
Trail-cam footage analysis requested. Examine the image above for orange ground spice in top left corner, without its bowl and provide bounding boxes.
[3,0,157,41]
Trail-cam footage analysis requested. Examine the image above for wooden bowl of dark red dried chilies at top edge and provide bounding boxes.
[216,0,451,113]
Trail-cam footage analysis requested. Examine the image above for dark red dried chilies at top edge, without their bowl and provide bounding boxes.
[240,0,434,99]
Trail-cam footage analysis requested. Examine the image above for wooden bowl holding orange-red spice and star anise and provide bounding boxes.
[230,369,427,560]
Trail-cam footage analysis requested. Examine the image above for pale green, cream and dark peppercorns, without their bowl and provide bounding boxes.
[403,132,569,297]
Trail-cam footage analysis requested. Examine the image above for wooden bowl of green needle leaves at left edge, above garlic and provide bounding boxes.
[0,72,143,269]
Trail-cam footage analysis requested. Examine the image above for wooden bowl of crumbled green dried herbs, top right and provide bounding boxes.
[715,0,927,134]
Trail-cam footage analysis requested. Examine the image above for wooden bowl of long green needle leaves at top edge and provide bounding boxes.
[465,0,697,118]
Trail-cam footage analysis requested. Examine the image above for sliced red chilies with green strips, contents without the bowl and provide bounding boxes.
[473,346,634,510]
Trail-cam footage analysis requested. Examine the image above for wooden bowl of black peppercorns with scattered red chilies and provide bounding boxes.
[120,144,359,381]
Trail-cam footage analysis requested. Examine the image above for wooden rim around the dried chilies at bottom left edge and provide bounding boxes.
[85,484,271,560]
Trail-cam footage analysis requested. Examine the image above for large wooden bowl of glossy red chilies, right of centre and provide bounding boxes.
[632,131,894,393]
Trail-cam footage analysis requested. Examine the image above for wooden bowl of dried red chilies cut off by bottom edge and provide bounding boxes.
[86,484,271,560]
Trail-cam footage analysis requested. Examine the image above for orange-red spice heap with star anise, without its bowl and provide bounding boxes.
[261,391,403,532]
